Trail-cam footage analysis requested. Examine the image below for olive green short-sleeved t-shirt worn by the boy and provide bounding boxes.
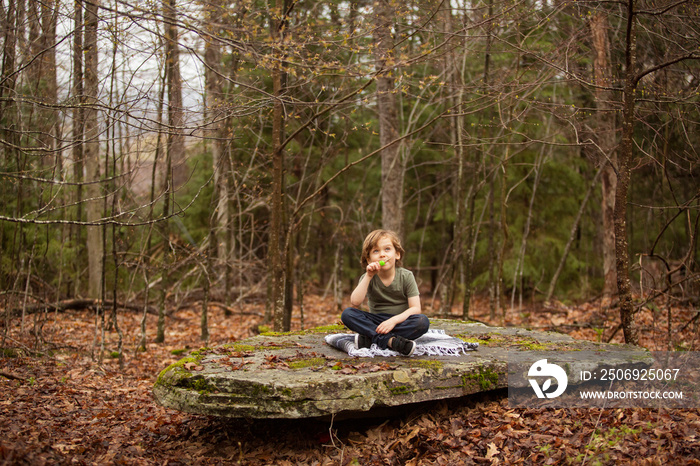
[360,267,420,315]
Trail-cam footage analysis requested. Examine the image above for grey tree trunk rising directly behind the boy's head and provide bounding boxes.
[375,0,404,236]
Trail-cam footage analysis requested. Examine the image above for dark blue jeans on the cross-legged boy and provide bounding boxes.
[340,307,430,349]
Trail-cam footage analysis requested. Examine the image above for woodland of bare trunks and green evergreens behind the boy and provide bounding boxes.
[0,0,700,343]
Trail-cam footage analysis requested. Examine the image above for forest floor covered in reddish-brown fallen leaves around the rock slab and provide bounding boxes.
[0,296,700,465]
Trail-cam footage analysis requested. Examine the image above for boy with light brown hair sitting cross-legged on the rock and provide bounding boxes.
[341,230,430,356]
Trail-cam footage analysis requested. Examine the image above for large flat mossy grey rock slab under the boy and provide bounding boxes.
[153,319,639,418]
